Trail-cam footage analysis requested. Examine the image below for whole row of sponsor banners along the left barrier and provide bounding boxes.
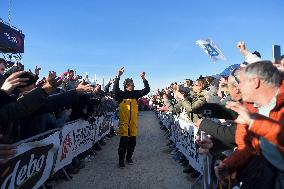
[0,113,116,189]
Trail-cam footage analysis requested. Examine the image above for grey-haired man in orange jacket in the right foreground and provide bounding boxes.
[215,61,284,188]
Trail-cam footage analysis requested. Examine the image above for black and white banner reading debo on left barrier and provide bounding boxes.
[0,131,60,189]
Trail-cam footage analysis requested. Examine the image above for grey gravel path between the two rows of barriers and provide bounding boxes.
[55,112,193,189]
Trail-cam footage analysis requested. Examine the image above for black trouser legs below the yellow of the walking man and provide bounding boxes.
[118,136,136,161]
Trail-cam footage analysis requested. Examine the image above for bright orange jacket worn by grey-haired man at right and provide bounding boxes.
[223,83,284,173]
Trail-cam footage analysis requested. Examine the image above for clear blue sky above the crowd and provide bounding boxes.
[0,0,284,89]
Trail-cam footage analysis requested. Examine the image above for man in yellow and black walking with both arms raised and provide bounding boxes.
[113,68,150,169]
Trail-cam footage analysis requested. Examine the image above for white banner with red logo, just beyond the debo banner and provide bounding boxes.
[54,119,97,172]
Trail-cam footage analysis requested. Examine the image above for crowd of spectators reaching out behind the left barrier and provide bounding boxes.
[0,58,122,186]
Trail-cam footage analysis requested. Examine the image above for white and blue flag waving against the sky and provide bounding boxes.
[196,39,226,62]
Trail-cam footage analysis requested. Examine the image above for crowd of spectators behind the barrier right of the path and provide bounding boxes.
[150,42,284,189]
